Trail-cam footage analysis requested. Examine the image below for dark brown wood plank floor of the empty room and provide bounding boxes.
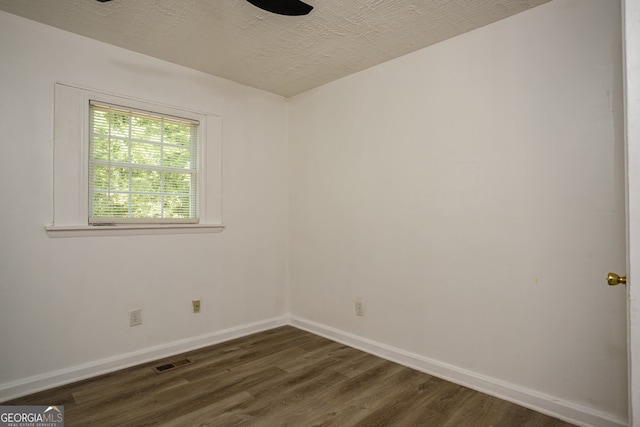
[4,326,571,427]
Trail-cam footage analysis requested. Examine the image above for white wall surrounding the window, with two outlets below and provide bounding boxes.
[0,12,288,400]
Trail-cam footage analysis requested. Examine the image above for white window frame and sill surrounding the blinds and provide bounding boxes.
[45,83,224,237]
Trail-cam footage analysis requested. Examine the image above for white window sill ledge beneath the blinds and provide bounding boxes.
[45,224,224,237]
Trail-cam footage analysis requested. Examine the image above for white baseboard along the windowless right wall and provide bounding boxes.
[289,316,628,427]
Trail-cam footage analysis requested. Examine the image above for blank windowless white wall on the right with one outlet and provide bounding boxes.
[289,0,627,424]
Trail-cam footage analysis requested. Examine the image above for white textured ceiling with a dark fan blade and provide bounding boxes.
[0,0,549,97]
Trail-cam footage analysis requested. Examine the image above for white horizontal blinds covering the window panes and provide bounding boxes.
[89,101,199,224]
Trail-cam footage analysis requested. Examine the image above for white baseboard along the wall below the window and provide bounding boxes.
[0,317,288,402]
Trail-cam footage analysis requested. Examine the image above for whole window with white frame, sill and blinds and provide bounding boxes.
[45,83,224,237]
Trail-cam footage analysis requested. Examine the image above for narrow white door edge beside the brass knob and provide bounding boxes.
[622,0,640,427]
